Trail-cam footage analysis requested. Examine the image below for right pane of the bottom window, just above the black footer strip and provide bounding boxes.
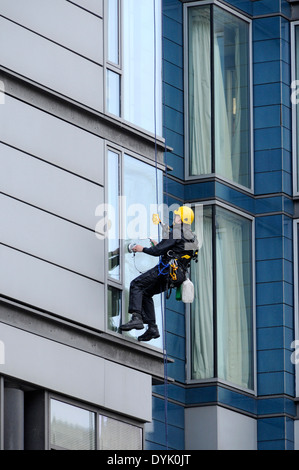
[99,416,142,450]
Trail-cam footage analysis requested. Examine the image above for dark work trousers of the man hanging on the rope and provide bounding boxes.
[128,266,185,325]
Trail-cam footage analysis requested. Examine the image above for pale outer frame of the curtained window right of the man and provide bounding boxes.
[186,200,257,396]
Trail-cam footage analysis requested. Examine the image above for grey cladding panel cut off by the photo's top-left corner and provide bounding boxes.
[0,0,103,64]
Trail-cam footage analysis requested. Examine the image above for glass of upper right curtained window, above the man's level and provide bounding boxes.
[188,5,251,188]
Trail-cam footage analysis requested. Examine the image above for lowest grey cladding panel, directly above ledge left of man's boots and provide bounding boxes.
[0,244,105,330]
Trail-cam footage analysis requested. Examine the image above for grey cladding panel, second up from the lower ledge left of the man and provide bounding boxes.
[0,194,104,282]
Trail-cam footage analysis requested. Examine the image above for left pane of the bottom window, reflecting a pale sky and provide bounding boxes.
[50,399,95,450]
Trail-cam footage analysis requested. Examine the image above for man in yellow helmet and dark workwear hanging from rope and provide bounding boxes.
[120,206,198,341]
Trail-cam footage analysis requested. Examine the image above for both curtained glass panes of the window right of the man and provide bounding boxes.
[190,206,254,389]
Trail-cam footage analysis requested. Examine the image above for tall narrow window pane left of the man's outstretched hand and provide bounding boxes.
[107,150,120,280]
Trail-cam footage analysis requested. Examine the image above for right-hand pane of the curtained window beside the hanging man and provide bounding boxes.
[216,208,253,388]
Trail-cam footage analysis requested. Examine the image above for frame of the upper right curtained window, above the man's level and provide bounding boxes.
[183,0,254,194]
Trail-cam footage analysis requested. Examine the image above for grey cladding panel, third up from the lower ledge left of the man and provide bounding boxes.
[0,143,104,230]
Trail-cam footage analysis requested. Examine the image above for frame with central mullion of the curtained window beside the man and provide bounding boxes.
[186,200,257,396]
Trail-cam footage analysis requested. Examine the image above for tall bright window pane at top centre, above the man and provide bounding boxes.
[123,0,162,135]
